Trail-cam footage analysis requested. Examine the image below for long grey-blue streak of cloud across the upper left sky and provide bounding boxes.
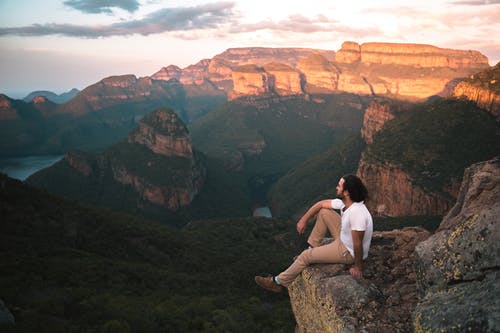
[0,2,234,38]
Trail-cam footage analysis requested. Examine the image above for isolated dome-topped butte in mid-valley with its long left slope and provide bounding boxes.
[27,109,206,223]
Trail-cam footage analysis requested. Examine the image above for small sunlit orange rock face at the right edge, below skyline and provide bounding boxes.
[453,63,500,121]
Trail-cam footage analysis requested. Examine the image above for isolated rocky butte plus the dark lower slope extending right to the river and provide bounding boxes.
[27,109,251,225]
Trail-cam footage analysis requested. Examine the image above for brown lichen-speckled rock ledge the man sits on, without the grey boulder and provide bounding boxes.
[288,228,429,333]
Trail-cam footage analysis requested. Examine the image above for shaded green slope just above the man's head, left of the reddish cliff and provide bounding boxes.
[269,135,365,218]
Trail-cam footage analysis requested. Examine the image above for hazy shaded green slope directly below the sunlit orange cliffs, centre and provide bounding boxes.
[189,94,366,179]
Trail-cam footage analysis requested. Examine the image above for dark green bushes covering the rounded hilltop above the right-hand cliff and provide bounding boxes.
[366,99,500,191]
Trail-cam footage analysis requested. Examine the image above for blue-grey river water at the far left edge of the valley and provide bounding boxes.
[0,155,64,180]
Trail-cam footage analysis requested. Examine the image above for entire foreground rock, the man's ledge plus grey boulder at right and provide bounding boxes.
[288,158,500,333]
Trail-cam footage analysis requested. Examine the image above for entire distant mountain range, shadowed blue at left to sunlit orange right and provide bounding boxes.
[0,42,489,156]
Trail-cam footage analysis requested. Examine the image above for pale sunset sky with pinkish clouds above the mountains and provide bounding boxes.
[0,0,500,98]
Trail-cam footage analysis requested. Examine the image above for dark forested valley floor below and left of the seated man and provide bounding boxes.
[0,175,299,332]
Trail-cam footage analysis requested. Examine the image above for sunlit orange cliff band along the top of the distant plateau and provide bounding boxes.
[152,42,489,100]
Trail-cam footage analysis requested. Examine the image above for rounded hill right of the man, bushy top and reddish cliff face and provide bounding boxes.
[357,98,500,216]
